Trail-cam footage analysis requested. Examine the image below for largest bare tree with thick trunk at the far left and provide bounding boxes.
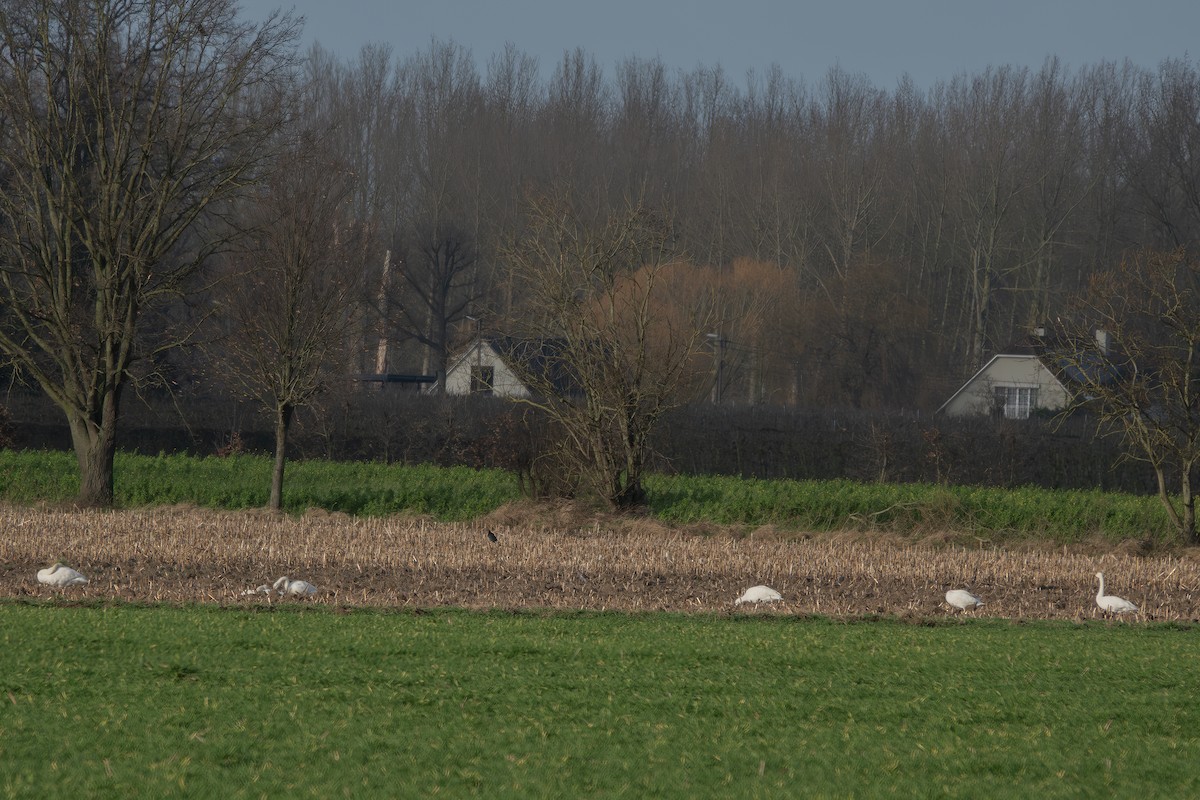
[0,0,298,505]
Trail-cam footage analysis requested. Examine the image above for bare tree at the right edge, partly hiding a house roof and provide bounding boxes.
[1057,248,1200,545]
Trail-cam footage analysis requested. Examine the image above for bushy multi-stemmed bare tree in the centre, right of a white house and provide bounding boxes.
[505,189,710,509]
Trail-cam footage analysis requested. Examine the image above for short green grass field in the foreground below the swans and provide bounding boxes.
[0,602,1200,798]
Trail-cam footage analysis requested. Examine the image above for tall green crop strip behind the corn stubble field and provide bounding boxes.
[0,450,1176,543]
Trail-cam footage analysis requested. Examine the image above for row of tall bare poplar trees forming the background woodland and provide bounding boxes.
[297,42,1200,409]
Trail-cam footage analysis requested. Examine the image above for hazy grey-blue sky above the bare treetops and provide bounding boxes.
[241,0,1200,89]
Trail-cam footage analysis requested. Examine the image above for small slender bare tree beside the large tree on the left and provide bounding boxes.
[218,137,364,510]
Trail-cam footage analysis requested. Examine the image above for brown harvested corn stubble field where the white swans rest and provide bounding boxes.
[0,506,1200,621]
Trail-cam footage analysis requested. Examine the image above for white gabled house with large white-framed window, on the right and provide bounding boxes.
[937,327,1109,420]
